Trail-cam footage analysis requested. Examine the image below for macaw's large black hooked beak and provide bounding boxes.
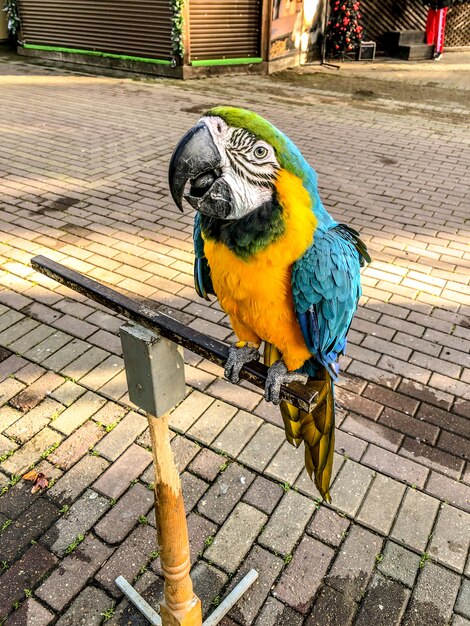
[168,122,233,219]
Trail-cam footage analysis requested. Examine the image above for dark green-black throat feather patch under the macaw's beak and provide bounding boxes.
[201,198,285,261]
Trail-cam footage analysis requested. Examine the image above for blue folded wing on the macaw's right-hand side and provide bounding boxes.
[292,224,370,379]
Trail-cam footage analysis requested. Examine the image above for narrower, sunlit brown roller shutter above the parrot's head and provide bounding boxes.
[189,0,261,61]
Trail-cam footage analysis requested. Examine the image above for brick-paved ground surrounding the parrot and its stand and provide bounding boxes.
[0,54,470,626]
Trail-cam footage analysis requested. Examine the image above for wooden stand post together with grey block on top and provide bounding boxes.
[120,324,202,626]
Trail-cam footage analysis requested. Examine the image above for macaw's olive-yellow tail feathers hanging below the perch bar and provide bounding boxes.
[264,343,335,502]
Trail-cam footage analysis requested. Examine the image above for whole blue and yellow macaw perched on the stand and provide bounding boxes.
[170,106,370,500]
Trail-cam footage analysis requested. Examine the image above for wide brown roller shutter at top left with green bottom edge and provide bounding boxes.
[19,0,171,60]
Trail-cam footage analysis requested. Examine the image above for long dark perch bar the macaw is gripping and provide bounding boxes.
[31,256,318,412]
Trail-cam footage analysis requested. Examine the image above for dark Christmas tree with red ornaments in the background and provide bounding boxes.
[326,0,364,57]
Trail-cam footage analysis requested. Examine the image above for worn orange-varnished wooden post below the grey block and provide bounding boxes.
[147,415,202,626]
